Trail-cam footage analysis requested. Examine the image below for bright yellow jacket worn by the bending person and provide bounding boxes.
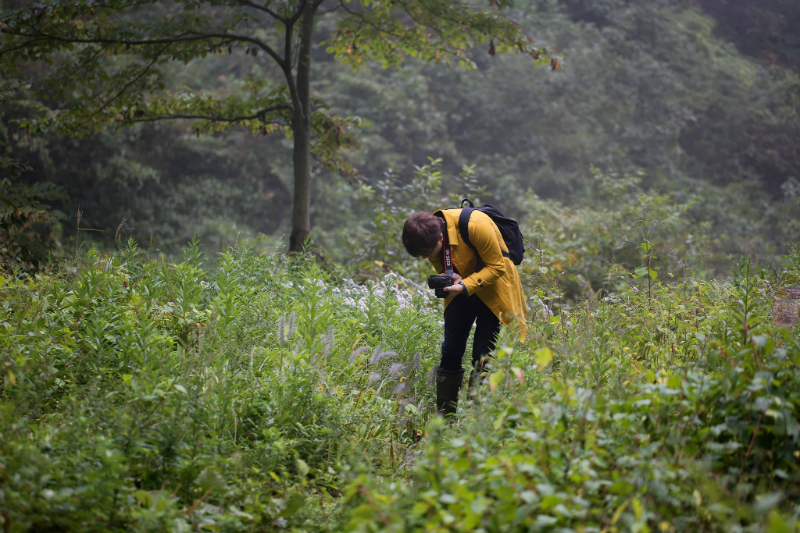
[428,209,528,338]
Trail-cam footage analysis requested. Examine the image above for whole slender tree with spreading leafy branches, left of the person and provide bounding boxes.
[0,0,559,249]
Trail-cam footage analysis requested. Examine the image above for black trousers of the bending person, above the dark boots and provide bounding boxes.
[439,293,500,371]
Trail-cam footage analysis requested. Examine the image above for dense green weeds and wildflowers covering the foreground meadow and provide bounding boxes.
[0,235,800,533]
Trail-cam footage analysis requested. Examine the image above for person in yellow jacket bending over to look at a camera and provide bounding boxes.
[403,209,527,416]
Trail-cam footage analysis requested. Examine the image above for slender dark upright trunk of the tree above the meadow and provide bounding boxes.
[289,2,317,252]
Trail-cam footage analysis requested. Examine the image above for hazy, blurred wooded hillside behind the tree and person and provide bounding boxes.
[0,0,800,270]
